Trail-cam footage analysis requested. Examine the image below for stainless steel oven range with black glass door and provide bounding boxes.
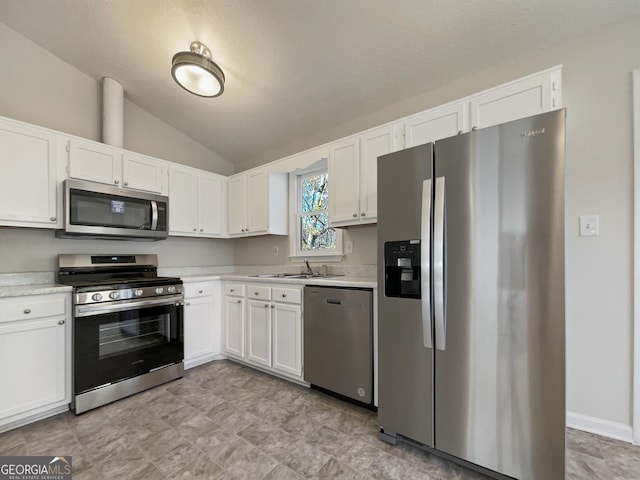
[58,254,184,414]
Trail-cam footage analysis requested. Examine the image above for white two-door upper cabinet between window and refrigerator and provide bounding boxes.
[328,125,400,227]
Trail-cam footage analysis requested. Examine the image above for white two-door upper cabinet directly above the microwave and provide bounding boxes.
[68,138,167,195]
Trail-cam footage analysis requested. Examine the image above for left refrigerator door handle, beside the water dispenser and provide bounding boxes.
[420,179,433,348]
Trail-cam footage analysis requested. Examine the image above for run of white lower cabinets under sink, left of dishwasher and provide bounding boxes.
[223,282,303,380]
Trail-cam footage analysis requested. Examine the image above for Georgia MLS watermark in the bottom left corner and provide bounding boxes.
[0,455,73,480]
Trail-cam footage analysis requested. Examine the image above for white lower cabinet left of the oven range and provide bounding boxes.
[0,294,71,431]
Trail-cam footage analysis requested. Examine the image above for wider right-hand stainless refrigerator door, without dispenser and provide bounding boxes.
[434,110,565,480]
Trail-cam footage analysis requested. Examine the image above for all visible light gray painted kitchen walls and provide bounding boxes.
[0,11,640,438]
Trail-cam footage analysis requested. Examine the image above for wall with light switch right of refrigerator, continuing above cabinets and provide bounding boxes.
[236,16,640,440]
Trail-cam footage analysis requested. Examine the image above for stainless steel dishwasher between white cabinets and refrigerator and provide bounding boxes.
[304,286,373,405]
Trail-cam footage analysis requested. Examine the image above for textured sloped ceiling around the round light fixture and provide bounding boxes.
[0,0,640,168]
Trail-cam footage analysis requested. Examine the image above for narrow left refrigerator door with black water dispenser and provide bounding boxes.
[378,144,433,446]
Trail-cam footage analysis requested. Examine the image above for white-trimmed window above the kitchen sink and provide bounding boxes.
[291,161,342,259]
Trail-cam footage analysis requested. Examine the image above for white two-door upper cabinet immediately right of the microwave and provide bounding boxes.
[169,164,227,237]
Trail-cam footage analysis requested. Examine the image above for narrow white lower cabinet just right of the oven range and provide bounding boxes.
[184,281,220,368]
